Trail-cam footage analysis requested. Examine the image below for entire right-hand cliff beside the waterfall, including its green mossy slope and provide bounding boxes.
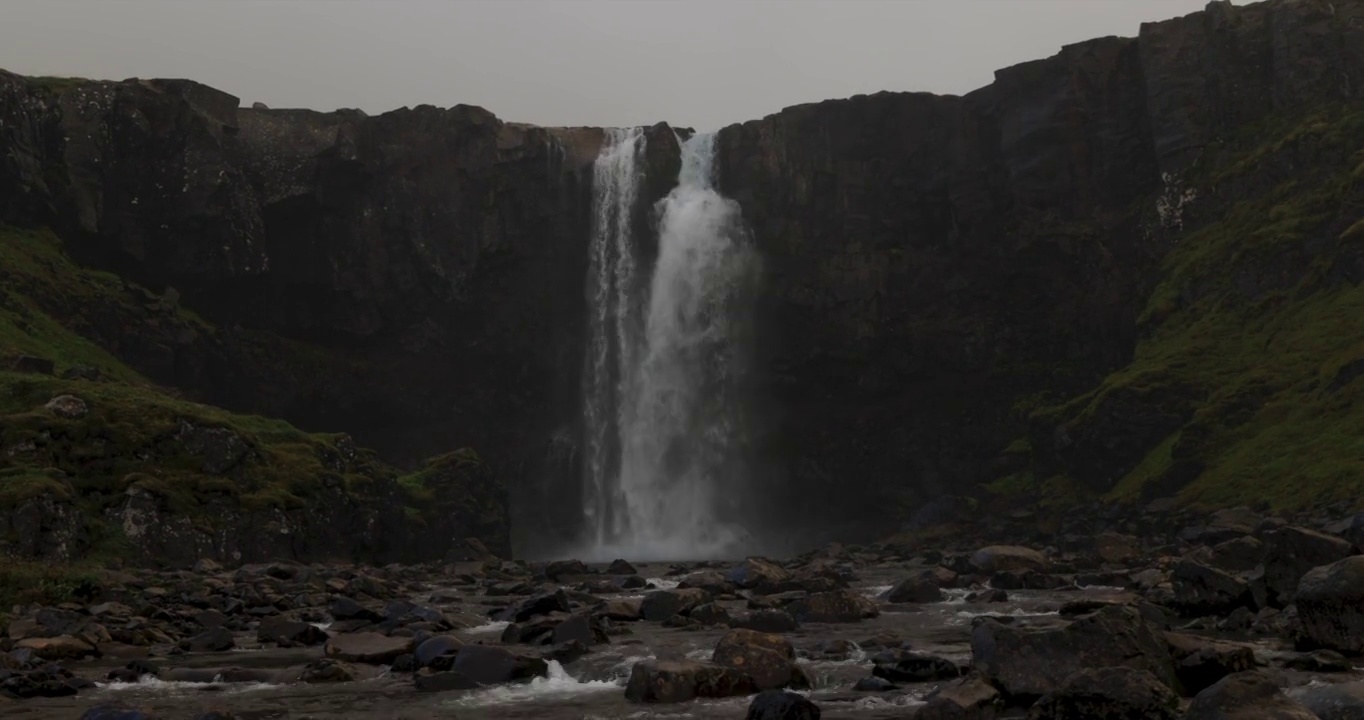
[720,1,1364,534]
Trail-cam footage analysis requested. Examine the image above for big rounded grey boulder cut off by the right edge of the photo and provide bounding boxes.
[1294,555,1364,655]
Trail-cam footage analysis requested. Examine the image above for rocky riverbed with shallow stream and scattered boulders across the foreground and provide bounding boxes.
[0,510,1364,720]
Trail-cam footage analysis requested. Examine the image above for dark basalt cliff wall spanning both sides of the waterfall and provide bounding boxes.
[0,0,1364,559]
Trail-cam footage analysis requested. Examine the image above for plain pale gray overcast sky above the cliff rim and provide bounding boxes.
[0,0,1211,130]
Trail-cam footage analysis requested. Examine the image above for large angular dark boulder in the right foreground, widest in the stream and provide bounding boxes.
[971,607,1178,700]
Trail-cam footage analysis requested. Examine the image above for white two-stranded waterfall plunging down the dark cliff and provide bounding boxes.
[573,128,760,562]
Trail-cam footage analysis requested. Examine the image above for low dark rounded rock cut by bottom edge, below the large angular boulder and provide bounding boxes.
[1028,667,1180,720]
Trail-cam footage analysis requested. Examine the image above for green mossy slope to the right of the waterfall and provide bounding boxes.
[1009,108,1364,510]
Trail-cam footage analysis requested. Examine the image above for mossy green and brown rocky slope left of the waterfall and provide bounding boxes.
[0,226,505,561]
